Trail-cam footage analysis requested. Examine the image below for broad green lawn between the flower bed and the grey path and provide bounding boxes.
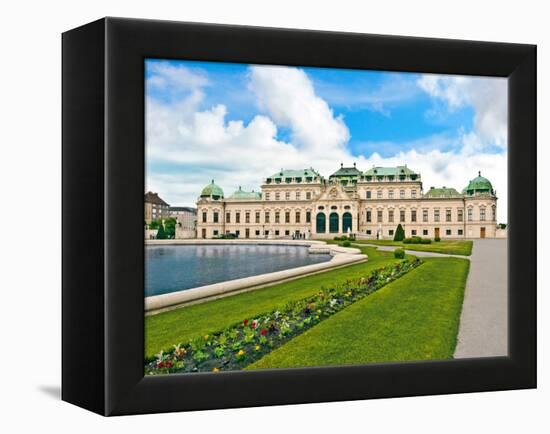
[247,258,470,369]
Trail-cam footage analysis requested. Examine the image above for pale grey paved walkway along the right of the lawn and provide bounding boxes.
[360,239,508,359]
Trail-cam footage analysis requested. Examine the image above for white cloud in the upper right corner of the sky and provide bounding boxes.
[417,74,508,150]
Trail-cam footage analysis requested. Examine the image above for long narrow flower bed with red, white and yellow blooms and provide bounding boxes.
[145,259,421,375]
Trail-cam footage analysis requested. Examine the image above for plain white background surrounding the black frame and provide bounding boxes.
[0,0,550,434]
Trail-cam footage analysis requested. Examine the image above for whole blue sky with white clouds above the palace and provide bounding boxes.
[145,60,507,220]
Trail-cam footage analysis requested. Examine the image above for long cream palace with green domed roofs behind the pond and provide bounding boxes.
[197,163,497,239]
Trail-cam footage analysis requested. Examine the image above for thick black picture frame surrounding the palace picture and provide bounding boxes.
[62,18,536,415]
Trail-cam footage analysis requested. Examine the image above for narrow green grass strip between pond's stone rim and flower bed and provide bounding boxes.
[145,247,398,357]
